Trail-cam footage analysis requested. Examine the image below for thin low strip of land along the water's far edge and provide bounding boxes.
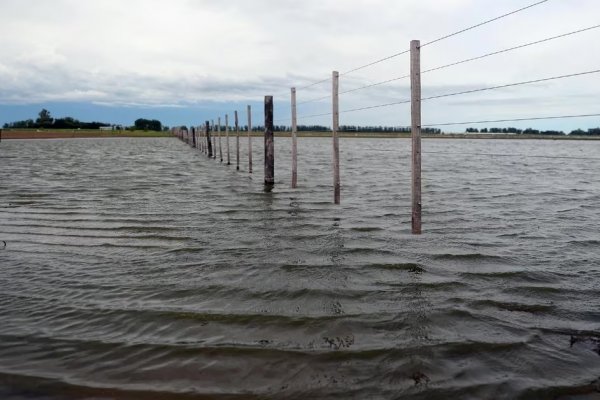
[1,129,600,140]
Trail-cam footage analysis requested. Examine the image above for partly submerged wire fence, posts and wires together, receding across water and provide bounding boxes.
[172,0,600,234]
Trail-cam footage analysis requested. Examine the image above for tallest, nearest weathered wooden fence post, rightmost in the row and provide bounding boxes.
[410,40,421,235]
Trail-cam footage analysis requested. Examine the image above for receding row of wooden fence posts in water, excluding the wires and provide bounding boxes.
[173,40,422,235]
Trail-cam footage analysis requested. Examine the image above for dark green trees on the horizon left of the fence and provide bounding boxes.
[3,108,168,132]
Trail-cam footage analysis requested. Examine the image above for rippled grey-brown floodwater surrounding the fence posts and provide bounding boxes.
[0,138,600,400]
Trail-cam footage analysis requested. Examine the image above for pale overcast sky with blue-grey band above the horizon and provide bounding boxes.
[0,0,600,131]
